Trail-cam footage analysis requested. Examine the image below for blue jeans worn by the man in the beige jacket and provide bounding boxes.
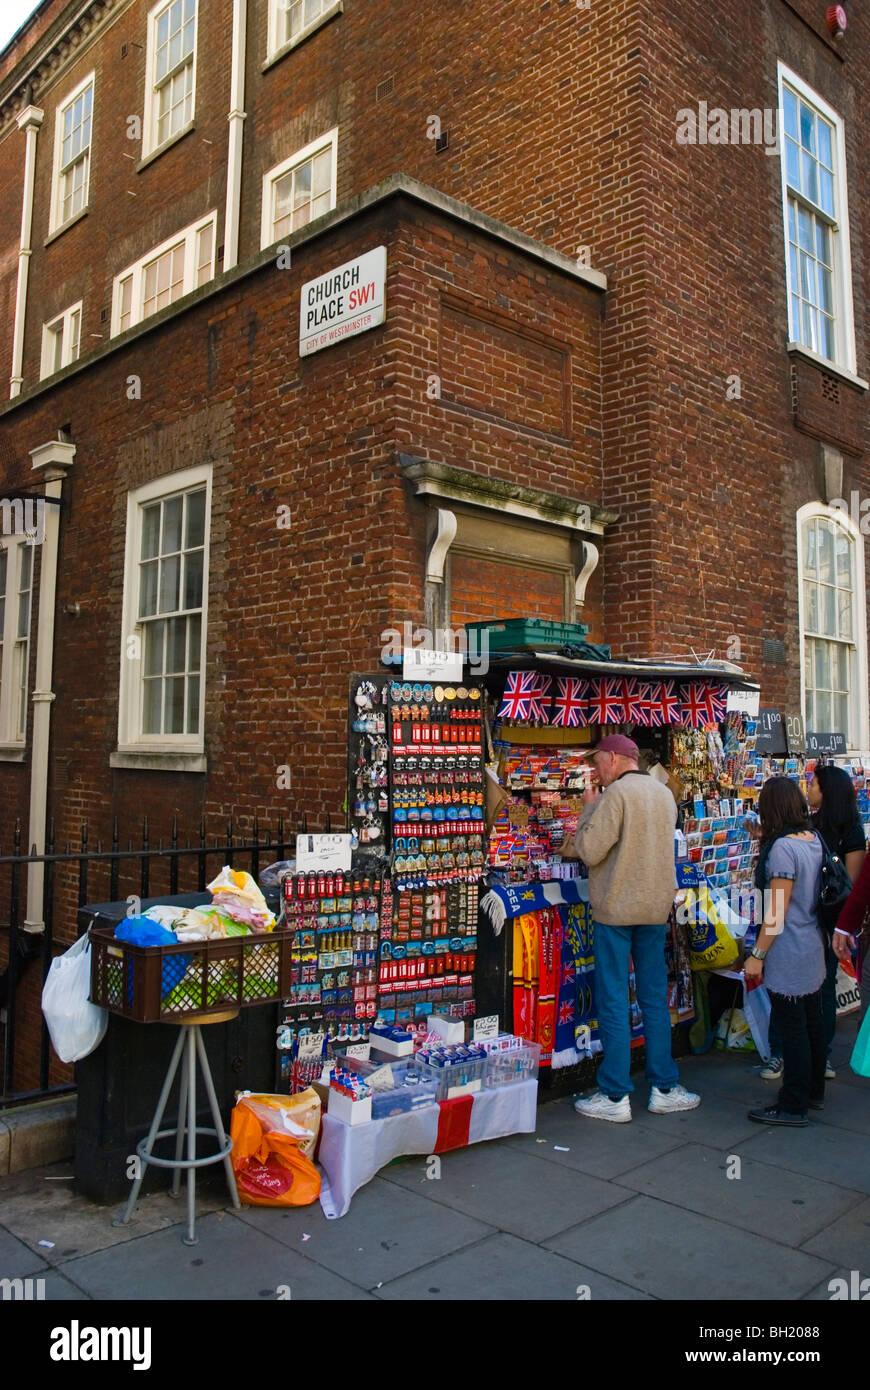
[595,922,680,1097]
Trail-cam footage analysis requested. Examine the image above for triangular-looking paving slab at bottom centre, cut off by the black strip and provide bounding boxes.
[377,1233,649,1302]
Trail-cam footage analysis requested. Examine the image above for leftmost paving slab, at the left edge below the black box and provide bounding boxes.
[0,1165,228,1265]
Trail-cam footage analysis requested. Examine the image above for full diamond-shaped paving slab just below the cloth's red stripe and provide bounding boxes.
[382,1144,627,1241]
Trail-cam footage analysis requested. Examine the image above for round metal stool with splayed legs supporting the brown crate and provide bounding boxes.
[113,1009,242,1245]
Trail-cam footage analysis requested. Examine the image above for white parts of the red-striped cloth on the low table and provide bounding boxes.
[318,1081,538,1218]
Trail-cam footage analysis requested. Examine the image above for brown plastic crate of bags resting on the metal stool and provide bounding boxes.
[90,927,293,1023]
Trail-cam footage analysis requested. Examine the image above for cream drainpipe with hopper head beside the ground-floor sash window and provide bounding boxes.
[24,439,75,931]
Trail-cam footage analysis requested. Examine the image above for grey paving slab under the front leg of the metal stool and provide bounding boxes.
[63,1212,370,1301]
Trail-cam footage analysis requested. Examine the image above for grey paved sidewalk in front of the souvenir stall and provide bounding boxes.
[0,1015,870,1301]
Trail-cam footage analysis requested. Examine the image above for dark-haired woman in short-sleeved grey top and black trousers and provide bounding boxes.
[745,777,826,1126]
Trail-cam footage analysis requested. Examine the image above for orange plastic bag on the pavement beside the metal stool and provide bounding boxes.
[229,1087,320,1207]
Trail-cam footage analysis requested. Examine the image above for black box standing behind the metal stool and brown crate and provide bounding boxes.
[74,892,278,1202]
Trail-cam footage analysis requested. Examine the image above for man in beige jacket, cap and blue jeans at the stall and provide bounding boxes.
[561,734,700,1125]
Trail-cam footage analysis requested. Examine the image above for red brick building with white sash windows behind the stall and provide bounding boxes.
[0,0,870,1084]
